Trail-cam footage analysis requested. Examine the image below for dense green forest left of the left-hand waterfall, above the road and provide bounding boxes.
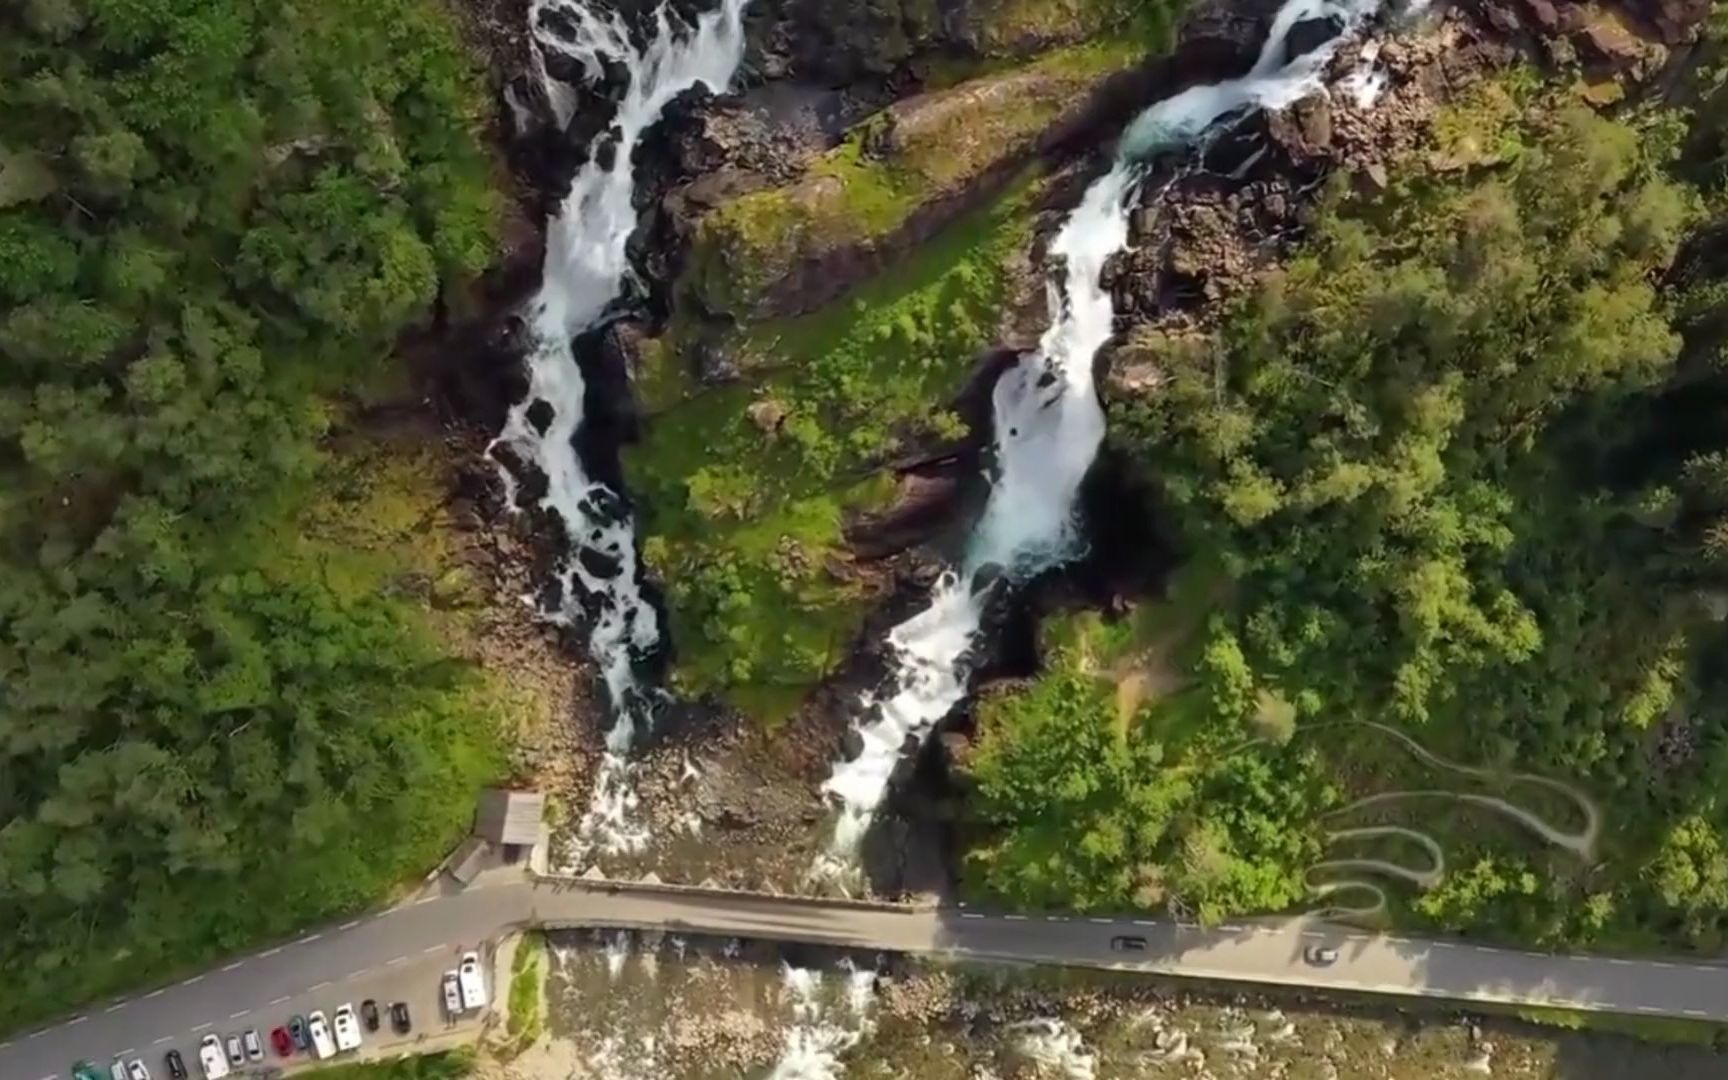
[0,0,498,1028]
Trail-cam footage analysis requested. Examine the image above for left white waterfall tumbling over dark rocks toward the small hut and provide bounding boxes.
[492,0,748,859]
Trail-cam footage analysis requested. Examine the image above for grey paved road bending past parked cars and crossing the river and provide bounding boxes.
[10,873,1728,1080]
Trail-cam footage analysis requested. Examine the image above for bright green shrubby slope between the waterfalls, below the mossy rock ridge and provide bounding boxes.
[626,185,1030,719]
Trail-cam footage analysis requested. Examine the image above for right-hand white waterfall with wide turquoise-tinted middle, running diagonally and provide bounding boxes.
[814,0,1377,867]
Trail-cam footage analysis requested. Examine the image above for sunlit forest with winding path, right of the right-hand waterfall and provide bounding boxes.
[969,48,1728,949]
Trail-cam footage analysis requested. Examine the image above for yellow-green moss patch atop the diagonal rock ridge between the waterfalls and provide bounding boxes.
[686,35,1146,314]
